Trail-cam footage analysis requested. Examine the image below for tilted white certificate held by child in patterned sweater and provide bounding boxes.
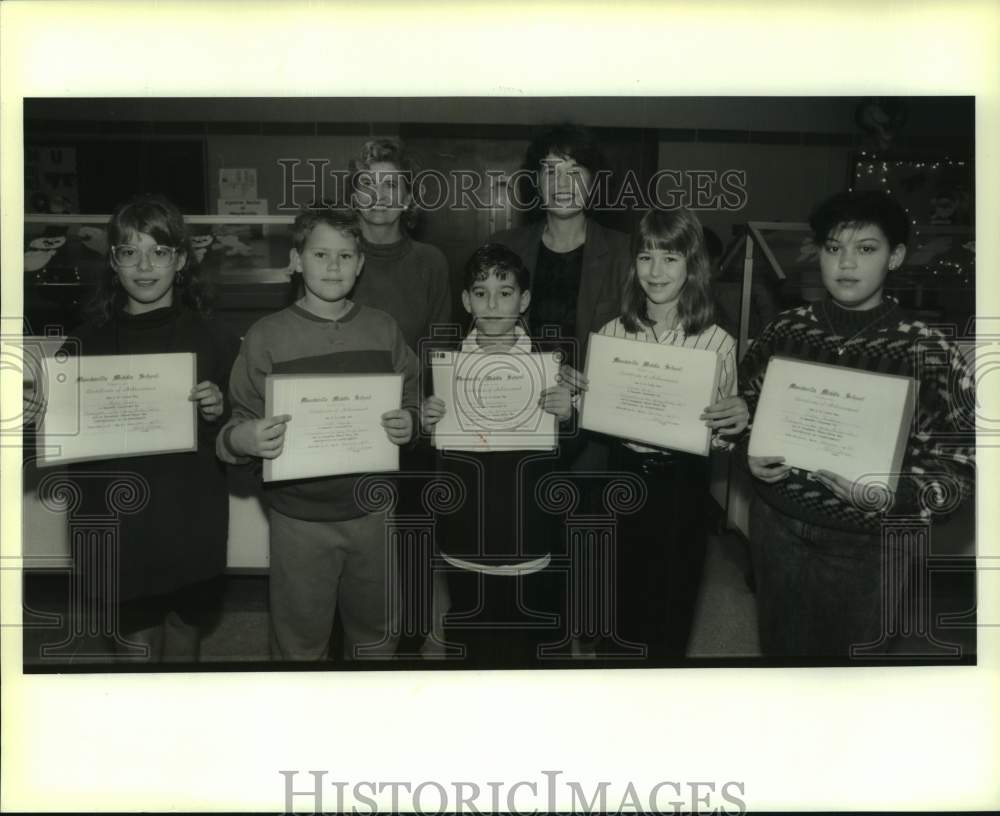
[747,357,915,490]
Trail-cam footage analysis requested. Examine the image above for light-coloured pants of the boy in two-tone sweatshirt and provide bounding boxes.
[268,510,400,660]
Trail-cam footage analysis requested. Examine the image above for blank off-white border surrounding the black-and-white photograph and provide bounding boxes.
[0,0,1000,812]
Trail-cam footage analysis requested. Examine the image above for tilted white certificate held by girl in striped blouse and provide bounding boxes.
[580,334,721,456]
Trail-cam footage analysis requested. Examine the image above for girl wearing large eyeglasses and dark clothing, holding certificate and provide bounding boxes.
[65,196,238,662]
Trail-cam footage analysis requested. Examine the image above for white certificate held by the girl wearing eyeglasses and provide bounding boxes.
[39,353,198,466]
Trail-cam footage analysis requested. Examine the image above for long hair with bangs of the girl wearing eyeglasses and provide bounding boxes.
[87,194,212,325]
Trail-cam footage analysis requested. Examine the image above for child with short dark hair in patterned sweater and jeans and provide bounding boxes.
[740,191,975,658]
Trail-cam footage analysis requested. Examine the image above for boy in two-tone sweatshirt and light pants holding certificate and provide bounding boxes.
[216,210,417,660]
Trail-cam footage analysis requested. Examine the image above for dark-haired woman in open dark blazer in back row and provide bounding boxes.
[491,124,631,658]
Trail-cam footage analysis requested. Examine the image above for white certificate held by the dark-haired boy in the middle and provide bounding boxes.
[431,349,559,452]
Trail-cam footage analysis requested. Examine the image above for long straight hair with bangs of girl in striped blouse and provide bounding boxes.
[622,212,715,334]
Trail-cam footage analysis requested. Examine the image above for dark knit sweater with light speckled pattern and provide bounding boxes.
[740,299,976,532]
